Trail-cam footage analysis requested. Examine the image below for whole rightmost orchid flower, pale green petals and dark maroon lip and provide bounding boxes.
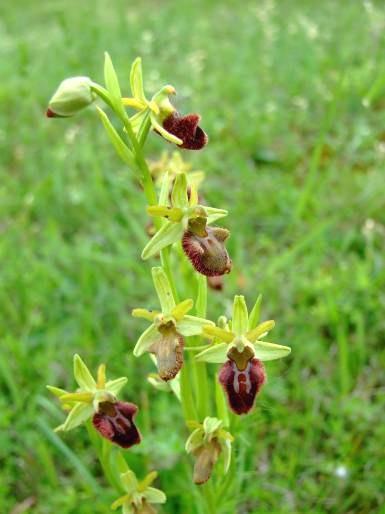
[195,296,291,414]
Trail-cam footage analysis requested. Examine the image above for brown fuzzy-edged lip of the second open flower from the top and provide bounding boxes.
[182,227,231,277]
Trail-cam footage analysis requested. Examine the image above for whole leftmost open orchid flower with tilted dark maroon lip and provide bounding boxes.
[47,355,140,448]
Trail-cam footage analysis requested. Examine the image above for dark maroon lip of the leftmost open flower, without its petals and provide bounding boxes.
[92,402,140,448]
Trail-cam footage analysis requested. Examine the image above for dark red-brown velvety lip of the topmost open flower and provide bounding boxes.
[163,112,208,150]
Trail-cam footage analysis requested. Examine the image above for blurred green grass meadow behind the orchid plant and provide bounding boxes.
[0,0,385,514]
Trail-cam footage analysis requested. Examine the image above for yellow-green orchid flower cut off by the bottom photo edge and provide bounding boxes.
[111,470,167,514]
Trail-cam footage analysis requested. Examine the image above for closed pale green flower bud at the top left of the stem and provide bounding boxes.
[46,77,95,118]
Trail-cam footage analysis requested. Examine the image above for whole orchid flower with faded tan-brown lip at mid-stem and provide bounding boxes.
[132,267,214,381]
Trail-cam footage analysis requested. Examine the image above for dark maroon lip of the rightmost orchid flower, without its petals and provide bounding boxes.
[218,359,266,414]
